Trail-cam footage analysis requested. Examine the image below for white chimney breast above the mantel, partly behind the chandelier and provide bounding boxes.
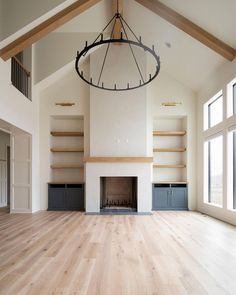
[90,45,148,156]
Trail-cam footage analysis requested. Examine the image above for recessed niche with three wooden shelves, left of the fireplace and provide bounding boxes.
[50,116,84,183]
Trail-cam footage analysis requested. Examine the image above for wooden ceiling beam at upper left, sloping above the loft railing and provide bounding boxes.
[0,0,101,60]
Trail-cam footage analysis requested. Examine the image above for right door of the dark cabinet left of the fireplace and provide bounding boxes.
[66,188,84,210]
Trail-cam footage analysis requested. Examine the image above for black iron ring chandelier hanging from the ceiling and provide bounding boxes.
[75,8,160,91]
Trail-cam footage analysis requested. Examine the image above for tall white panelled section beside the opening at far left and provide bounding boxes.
[10,133,32,212]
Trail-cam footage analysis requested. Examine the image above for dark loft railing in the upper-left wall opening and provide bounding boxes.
[11,56,30,99]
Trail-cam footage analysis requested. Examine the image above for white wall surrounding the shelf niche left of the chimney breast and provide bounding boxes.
[35,61,89,210]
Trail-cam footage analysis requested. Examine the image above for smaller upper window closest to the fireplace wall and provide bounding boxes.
[204,91,223,130]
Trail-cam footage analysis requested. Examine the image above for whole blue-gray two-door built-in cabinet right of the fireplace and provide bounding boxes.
[152,183,188,210]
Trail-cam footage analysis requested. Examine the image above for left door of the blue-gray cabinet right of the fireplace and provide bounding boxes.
[152,187,170,210]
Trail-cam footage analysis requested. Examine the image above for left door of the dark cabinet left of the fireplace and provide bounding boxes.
[48,188,65,210]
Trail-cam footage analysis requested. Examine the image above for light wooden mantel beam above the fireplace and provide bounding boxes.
[84,157,153,163]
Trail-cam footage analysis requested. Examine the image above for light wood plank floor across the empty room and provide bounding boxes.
[0,212,236,295]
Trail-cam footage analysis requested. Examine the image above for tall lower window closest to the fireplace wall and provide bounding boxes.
[205,136,223,206]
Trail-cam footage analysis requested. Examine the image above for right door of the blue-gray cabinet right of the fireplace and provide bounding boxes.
[169,187,188,210]
